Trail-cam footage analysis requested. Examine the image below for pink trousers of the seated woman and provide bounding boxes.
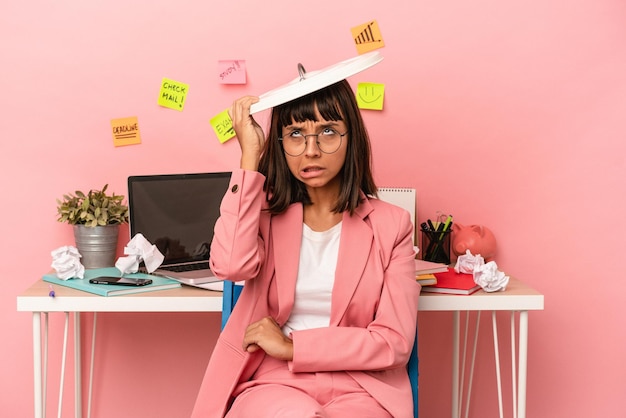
[226,356,393,418]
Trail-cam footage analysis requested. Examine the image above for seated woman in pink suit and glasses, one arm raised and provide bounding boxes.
[193,80,420,418]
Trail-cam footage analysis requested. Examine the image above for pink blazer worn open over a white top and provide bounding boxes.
[192,170,420,418]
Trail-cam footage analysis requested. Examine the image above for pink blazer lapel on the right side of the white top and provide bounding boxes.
[330,196,374,326]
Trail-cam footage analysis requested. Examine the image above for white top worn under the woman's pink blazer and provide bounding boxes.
[283,222,341,336]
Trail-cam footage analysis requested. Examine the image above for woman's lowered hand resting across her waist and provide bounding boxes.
[243,316,293,360]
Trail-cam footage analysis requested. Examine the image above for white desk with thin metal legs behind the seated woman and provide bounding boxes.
[17,278,543,418]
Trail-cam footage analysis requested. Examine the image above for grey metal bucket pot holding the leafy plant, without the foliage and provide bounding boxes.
[74,225,120,269]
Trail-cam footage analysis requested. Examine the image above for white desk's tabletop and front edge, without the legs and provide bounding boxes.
[17,278,543,312]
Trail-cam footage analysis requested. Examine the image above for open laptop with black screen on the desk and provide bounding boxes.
[128,172,231,290]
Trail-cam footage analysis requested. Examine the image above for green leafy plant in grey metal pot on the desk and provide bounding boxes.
[57,184,128,268]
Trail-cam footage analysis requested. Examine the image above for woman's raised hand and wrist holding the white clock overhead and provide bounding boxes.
[228,96,265,171]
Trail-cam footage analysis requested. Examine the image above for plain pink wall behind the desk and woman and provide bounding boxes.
[0,0,626,418]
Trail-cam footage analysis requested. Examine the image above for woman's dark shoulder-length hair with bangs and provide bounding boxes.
[258,80,377,214]
